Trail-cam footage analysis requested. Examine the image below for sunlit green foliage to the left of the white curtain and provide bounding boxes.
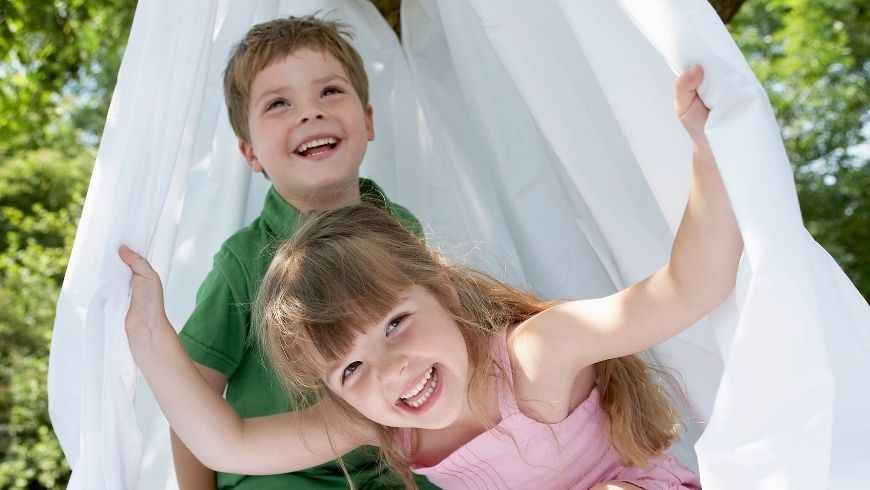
[0,0,136,488]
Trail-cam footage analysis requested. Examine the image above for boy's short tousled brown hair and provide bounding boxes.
[224,15,369,143]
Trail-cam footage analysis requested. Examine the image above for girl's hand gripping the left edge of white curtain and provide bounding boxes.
[118,245,168,341]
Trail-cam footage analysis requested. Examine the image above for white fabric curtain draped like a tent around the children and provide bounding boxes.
[49,0,870,489]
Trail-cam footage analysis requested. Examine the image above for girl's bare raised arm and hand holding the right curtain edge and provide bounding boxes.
[517,66,743,370]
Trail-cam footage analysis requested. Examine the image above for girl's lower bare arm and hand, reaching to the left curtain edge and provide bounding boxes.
[119,246,376,475]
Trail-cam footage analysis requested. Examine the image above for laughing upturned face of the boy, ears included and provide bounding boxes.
[239,48,375,210]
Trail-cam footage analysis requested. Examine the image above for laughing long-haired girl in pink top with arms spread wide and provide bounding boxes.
[121,67,742,488]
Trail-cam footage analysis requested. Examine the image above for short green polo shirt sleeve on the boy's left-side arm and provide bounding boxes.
[179,249,250,378]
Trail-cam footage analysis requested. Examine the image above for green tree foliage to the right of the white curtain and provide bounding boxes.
[730,0,870,298]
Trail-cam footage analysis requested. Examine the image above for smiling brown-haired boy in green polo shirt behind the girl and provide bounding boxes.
[172,16,431,490]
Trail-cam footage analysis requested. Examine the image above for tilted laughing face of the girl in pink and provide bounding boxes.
[326,286,470,429]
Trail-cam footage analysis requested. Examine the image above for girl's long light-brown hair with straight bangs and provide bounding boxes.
[255,205,677,488]
